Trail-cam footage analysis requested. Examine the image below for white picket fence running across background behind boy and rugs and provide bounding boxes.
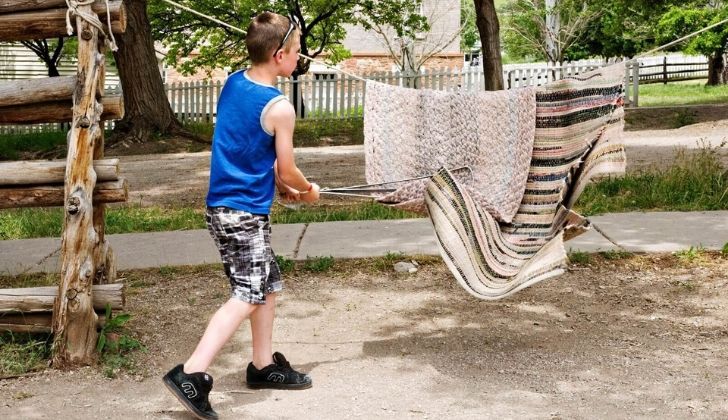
[0,57,708,134]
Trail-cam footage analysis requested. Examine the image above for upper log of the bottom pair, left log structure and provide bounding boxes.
[0,283,126,315]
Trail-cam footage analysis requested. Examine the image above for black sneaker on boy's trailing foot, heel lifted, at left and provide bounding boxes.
[162,365,217,420]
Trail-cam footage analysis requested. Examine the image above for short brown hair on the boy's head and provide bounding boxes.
[245,12,301,64]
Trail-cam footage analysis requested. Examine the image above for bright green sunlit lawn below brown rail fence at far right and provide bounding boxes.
[640,80,728,106]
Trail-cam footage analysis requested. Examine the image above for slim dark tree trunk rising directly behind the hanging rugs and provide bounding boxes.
[473,0,503,90]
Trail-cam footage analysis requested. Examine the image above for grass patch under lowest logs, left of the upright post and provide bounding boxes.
[0,332,51,377]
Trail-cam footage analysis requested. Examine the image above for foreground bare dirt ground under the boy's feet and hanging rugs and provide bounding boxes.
[0,255,728,419]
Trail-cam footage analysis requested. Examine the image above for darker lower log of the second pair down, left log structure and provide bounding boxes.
[0,96,124,124]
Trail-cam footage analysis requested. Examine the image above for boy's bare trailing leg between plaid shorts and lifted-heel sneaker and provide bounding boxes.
[184,298,258,373]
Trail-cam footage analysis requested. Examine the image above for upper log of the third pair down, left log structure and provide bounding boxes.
[0,159,119,188]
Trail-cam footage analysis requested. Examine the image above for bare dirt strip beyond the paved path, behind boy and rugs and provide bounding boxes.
[115,120,728,207]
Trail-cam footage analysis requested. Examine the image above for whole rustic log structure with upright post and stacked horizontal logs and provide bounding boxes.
[0,0,128,367]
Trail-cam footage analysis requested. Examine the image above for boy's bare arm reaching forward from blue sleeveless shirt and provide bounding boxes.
[264,101,319,202]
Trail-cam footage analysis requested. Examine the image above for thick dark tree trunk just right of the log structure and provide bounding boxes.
[108,0,183,144]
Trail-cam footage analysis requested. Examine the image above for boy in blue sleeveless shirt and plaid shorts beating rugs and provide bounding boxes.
[163,12,319,419]
